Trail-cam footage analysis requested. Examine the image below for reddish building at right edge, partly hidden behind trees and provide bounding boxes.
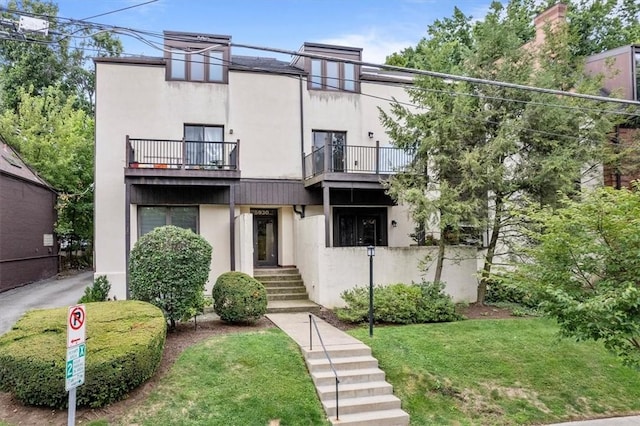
[585,45,640,189]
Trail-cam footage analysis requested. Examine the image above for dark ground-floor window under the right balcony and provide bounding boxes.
[333,207,387,247]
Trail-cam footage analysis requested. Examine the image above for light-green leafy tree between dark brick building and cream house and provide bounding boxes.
[0,87,94,256]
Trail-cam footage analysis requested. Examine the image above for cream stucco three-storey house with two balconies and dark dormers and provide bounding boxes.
[95,32,477,307]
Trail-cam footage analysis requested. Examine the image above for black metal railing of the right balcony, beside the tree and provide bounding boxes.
[304,143,414,179]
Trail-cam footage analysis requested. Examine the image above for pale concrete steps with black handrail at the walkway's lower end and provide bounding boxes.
[302,339,409,426]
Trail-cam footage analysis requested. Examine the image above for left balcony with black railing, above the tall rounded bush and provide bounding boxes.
[126,136,240,178]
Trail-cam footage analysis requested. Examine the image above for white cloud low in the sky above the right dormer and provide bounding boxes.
[320,30,418,64]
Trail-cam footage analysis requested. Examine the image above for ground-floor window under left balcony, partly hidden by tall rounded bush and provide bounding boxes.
[138,206,198,236]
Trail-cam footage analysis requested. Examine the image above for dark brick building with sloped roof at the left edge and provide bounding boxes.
[0,140,58,292]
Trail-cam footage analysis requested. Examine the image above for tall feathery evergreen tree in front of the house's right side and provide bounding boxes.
[381,0,622,303]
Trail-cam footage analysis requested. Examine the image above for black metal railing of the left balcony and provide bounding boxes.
[127,136,240,170]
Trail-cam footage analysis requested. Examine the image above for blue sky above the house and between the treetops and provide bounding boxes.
[54,0,498,62]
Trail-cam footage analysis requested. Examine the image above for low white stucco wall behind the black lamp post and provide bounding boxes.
[297,216,477,307]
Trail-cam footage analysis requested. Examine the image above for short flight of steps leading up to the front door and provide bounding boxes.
[253,267,320,314]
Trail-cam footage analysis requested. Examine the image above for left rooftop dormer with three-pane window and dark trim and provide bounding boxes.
[164,31,231,83]
